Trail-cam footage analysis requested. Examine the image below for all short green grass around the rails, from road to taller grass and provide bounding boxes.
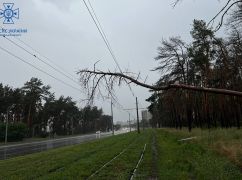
[0,129,242,180]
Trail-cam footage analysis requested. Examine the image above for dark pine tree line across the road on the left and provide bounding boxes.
[0,78,112,139]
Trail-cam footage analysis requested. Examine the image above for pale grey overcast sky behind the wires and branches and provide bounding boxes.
[0,0,226,121]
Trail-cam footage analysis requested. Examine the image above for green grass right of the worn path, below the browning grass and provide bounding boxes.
[155,131,242,179]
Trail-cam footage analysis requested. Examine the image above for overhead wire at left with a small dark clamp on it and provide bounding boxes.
[3,36,79,85]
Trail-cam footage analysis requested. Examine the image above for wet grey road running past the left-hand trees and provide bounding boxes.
[0,132,112,160]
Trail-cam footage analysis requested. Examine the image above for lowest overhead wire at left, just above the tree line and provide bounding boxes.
[0,46,80,92]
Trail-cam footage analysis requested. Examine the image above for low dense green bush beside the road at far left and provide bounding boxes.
[0,123,27,141]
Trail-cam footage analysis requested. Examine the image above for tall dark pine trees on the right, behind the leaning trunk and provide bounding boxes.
[147,3,242,130]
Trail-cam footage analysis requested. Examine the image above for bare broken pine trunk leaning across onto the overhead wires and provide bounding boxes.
[78,69,242,99]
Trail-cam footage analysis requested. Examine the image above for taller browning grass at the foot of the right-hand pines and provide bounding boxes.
[166,128,242,169]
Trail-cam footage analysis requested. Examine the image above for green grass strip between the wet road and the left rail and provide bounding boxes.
[0,133,137,180]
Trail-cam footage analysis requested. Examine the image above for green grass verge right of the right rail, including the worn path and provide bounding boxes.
[136,129,242,180]
